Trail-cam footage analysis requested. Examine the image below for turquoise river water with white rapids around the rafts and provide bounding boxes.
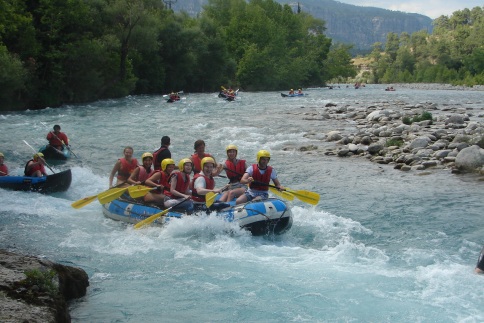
[0,86,484,322]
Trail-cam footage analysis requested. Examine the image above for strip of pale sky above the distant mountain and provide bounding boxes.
[337,0,484,19]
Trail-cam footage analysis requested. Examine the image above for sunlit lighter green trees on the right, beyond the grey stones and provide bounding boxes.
[361,7,484,86]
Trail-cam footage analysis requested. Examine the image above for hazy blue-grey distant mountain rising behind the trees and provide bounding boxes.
[172,0,432,53]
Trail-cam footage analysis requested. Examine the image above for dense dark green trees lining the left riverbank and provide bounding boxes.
[0,0,355,111]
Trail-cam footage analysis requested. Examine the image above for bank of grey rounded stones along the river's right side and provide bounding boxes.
[288,96,484,179]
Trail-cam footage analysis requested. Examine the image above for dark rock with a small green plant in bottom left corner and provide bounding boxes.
[0,250,89,322]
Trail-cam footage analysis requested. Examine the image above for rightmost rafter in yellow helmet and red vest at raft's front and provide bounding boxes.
[235,150,284,204]
